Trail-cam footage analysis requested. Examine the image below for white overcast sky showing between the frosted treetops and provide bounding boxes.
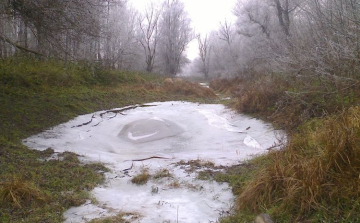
[129,0,237,60]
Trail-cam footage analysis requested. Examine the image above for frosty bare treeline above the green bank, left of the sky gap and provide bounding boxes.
[0,0,194,76]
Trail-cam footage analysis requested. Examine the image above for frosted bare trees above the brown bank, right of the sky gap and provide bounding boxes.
[187,0,360,82]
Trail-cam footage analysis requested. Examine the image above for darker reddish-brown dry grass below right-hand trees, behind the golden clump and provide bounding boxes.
[210,74,360,130]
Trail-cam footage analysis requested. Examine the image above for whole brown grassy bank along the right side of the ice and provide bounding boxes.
[211,75,360,222]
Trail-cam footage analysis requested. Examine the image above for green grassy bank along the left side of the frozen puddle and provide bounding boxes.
[0,58,215,222]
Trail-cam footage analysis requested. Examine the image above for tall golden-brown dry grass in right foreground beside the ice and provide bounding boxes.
[237,107,360,222]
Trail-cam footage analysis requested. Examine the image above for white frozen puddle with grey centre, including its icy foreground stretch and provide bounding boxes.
[24,102,278,223]
